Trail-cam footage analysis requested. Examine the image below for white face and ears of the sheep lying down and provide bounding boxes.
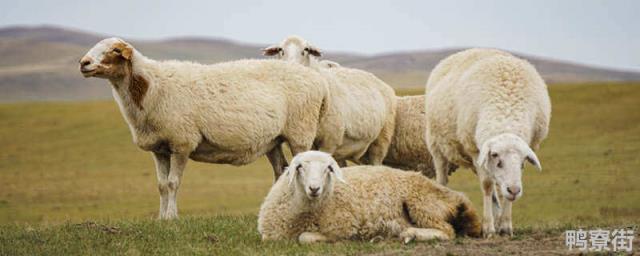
[287,151,345,201]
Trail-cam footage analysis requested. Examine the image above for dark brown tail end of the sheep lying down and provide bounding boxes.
[449,198,482,237]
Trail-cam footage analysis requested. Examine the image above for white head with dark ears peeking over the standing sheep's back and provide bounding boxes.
[262,36,322,66]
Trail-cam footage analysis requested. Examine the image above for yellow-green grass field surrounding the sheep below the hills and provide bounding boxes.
[0,84,640,255]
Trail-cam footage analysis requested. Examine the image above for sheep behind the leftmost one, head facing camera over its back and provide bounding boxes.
[263,36,396,166]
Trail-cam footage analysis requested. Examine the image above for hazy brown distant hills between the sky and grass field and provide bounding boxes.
[0,26,640,101]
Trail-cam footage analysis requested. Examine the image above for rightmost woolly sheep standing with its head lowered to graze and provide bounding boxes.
[425,49,551,237]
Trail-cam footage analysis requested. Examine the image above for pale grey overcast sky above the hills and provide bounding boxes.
[0,0,640,71]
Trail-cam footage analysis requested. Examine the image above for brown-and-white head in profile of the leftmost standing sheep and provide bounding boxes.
[80,37,134,79]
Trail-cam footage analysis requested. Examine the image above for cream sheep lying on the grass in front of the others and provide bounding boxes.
[258,151,481,243]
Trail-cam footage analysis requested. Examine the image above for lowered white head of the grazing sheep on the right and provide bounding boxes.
[477,133,542,201]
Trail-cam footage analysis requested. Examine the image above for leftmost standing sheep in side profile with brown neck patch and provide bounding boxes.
[80,38,339,219]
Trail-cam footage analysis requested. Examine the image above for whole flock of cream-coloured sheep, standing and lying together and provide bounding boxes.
[80,36,551,243]
